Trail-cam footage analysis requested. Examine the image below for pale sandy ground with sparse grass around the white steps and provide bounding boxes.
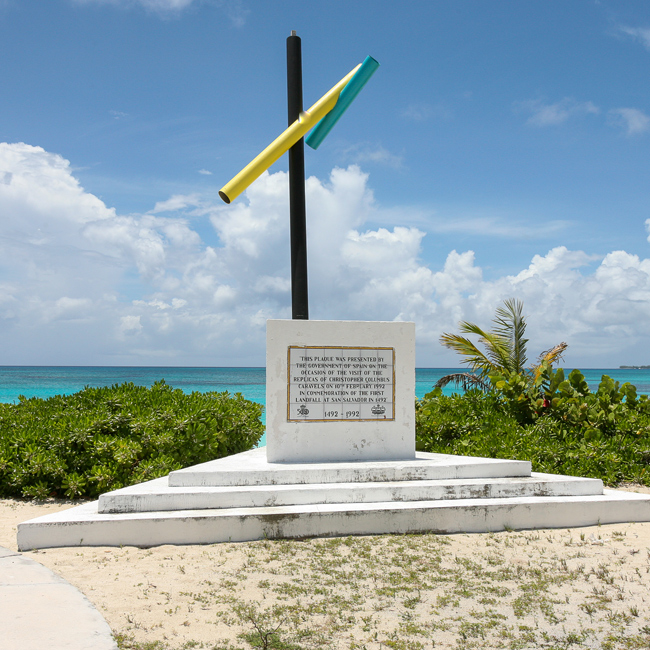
[0,487,650,650]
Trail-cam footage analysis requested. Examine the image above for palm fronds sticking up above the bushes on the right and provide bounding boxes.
[435,298,567,390]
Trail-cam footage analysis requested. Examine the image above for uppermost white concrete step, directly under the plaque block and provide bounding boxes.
[169,447,530,487]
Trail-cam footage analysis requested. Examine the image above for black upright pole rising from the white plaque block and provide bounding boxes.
[287,31,309,320]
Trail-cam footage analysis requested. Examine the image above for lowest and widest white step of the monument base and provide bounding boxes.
[18,490,650,551]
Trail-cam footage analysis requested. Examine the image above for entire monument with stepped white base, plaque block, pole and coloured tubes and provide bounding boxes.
[18,32,650,550]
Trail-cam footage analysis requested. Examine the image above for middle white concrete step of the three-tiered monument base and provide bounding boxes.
[98,474,603,513]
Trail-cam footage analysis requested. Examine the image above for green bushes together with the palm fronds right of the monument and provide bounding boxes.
[416,300,650,485]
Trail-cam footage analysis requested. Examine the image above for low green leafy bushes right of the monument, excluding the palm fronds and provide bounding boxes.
[416,368,650,485]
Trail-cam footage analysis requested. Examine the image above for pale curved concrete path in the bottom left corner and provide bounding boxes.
[0,546,117,650]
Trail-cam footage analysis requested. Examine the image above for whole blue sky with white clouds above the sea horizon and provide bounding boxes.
[0,0,650,368]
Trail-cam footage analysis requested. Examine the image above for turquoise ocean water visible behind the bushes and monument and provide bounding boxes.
[0,366,650,444]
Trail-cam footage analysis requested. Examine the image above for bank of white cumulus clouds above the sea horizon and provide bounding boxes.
[0,143,650,366]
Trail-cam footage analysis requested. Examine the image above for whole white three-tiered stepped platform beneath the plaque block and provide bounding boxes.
[18,448,650,551]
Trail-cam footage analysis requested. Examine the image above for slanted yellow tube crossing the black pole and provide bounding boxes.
[219,64,361,203]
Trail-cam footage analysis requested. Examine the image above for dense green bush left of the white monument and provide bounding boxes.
[0,381,264,499]
